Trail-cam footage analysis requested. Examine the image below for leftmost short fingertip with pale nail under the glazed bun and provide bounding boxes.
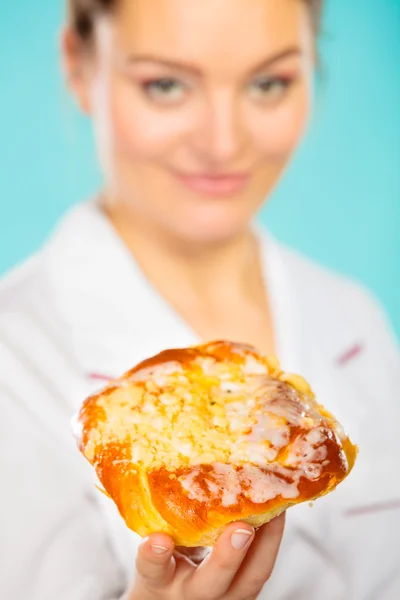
[136,533,175,588]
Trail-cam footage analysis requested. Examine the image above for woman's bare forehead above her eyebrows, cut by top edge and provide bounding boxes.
[105,0,311,66]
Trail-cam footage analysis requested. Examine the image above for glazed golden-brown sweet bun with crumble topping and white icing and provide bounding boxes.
[76,342,357,546]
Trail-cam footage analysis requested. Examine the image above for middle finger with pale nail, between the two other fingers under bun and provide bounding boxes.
[187,523,254,600]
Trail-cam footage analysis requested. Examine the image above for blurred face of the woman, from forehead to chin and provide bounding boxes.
[69,0,314,242]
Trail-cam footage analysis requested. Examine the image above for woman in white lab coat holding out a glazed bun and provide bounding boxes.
[0,0,400,600]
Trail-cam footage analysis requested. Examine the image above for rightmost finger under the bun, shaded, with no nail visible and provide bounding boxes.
[231,514,285,600]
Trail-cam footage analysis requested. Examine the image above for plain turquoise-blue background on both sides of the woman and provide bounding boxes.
[0,0,400,332]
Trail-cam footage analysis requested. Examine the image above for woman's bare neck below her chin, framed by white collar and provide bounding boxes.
[103,200,259,307]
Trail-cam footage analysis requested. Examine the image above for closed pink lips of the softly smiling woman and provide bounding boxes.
[176,173,249,197]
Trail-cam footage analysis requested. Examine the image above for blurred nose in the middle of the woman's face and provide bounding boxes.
[192,93,246,168]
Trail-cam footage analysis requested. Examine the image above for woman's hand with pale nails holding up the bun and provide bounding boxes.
[128,515,285,600]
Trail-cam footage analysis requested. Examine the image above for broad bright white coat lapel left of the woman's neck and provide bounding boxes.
[45,201,195,376]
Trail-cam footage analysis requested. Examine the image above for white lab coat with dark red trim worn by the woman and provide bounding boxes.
[0,203,400,600]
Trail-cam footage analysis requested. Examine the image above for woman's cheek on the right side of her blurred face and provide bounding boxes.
[254,86,310,161]
